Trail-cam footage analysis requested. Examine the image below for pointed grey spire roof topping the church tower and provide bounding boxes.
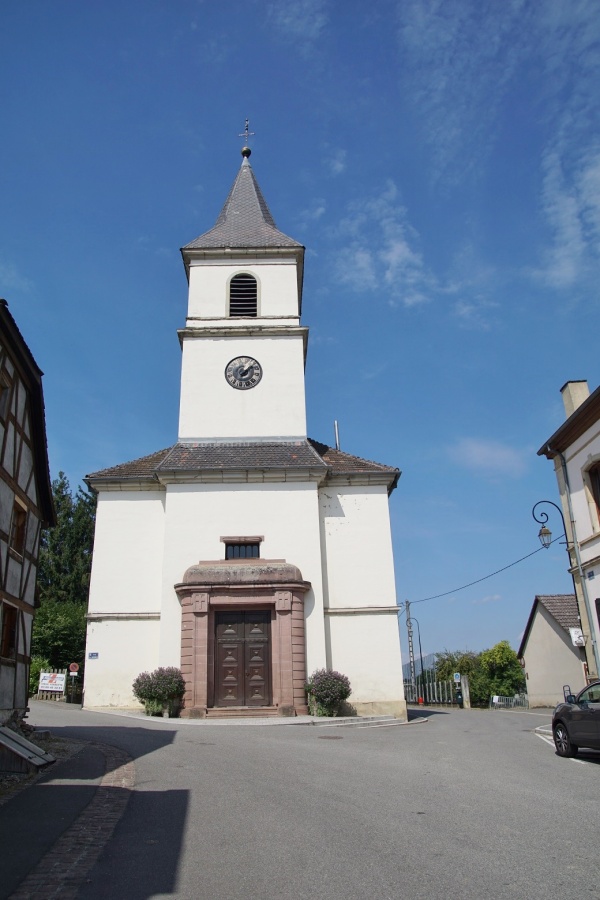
[182,159,303,252]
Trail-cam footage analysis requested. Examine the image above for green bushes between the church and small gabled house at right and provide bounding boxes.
[435,641,525,706]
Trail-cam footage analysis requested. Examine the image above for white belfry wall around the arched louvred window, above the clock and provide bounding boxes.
[188,256,298,327]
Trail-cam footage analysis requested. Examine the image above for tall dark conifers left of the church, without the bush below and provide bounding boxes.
[38,472,96,604]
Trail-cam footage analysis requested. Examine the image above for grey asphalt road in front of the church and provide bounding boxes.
[22,704,600,900]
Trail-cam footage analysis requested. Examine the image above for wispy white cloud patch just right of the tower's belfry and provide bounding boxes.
[335,180,435,306]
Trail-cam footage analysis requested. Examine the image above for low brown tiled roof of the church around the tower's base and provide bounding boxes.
[86,439,400,493]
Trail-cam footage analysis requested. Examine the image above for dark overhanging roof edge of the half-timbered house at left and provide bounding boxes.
[0,299,56,525]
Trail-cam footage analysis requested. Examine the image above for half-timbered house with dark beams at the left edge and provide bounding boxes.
[0,300,55,724]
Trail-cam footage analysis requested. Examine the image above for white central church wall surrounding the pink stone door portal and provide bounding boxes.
[160,482,326,669]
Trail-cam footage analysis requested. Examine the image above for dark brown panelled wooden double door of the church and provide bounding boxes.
[215,609,272,707]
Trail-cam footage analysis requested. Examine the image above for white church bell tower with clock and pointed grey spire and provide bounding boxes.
[178,147,308,444]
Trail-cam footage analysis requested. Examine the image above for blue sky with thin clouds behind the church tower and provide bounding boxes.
[0,0,600,653]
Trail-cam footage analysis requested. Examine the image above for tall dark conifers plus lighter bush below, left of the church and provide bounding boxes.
[31,472,96,669]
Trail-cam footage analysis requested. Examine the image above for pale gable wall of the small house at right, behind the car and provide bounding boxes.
[523,603,585,707]
